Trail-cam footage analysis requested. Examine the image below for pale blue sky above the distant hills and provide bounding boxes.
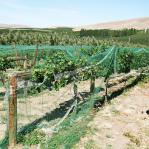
[0,0,149,27]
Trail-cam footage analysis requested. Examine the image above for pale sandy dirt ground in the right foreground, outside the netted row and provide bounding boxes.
[75,83,149,149]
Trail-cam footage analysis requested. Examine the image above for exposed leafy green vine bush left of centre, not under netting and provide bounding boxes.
[32,50,87,89]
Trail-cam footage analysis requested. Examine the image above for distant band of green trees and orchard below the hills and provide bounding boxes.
[0,28,149,46]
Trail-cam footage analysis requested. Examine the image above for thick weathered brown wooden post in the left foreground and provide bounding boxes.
[8,76,17,147]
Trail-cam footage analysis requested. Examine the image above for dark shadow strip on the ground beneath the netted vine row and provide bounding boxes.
[0,78,141,149]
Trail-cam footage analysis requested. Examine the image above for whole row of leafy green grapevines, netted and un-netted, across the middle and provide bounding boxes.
[0,46,149,91]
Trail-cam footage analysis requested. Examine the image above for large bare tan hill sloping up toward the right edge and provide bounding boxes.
[73,17,149,31]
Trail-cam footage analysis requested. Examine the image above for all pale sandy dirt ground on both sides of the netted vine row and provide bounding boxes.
[0,80,149,149]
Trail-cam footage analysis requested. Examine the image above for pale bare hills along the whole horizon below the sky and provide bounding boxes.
[0,17,149,31]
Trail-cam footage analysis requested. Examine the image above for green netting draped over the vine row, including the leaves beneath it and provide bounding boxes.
[0,45,149,87]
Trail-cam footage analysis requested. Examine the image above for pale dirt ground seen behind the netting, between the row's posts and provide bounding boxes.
[0,80,102,139]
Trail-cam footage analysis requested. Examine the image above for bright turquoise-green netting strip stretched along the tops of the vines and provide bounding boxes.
[0,45,149,70]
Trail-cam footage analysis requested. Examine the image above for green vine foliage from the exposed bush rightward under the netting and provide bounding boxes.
[30,47,149,92]
